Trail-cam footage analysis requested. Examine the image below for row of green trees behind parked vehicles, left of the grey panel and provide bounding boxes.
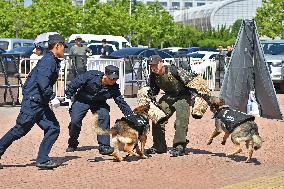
[0,0,244,47]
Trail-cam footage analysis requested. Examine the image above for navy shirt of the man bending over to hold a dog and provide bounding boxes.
[65,70,133,116]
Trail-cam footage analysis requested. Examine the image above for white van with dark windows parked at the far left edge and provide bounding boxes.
[0,38,34,51]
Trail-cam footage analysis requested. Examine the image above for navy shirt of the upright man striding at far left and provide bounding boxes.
[23,51,61,105]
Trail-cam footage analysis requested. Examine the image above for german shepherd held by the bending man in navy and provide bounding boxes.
[94,105,150,161]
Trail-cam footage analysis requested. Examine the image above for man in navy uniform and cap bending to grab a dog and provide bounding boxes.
[65,65,144,155]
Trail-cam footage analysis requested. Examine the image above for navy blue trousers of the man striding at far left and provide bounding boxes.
[0,100,60,163]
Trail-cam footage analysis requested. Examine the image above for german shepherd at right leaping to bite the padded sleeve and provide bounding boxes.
[207,97,262,162]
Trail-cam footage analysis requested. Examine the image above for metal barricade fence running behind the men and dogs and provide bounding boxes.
[0,55,219,104]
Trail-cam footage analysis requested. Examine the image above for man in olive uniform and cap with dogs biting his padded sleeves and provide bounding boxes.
[147,55,191,156]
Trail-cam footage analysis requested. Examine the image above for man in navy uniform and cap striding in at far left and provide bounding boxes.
[0,34,66,169]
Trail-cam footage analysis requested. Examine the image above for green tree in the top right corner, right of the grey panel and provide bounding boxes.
[255,0,284,38]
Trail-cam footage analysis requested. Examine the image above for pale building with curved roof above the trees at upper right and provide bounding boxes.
[171,0,262,30]
